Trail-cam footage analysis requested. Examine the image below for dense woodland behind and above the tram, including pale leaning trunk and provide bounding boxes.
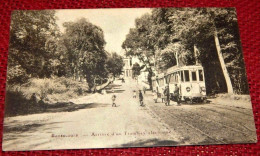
[122,8,248,94]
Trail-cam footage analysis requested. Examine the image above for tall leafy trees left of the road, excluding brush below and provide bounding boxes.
[7,10,124,90]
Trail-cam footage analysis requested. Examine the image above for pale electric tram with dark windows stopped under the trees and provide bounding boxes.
[152,65,207,103]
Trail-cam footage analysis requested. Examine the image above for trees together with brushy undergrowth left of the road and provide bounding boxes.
[5,10,124,116]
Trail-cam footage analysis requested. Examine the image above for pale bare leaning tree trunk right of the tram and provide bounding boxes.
[214,28,234,94]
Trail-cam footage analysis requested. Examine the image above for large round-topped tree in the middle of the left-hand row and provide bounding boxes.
[62,18,107,89]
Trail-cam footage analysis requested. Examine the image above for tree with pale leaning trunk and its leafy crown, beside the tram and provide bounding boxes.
[161,8,245,94]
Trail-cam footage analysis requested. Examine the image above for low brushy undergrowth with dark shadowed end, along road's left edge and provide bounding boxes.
[6,77,88,115]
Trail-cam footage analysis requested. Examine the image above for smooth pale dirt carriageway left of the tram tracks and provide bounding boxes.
[3,80,181,150]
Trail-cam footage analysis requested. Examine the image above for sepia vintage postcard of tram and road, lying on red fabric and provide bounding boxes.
[2,8,257,151]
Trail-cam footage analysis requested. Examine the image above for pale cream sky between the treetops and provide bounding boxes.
[56,8,151,55]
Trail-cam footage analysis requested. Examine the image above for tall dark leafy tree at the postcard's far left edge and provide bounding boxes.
[8,10,58,81]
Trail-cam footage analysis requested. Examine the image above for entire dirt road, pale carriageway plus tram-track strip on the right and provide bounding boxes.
[3,79,256,150]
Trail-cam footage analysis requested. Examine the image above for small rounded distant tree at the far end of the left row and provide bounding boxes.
[106,52,124,77]
